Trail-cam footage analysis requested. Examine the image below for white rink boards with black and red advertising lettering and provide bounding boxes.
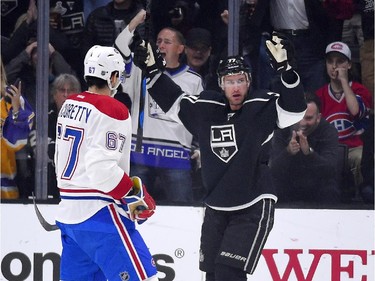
[0,204,375,281]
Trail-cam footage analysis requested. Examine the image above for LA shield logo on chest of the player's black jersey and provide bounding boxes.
[211,125,238,163]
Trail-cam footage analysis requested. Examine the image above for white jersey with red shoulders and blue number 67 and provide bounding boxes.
[55,92,132,223]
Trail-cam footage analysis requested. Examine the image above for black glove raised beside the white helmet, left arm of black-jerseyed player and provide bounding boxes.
[133,40,166,84]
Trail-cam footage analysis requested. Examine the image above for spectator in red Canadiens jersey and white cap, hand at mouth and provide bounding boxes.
[316,42,372,200]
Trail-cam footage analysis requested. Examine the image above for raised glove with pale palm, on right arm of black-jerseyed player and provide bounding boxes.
[266,32,294,73]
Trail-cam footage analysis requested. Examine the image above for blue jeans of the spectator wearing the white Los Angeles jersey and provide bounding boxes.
[130,163,193,203]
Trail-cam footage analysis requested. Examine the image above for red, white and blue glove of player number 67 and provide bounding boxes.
[124,177,156,223]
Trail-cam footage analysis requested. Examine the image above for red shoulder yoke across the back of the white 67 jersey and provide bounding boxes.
[68,92,129,120]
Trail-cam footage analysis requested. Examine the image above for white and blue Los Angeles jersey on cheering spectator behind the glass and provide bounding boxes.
[123,64,203,170]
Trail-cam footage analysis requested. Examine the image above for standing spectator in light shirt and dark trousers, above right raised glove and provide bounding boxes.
[259,0,328,92]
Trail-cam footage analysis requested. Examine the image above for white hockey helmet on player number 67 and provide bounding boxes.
[84,45,125,90]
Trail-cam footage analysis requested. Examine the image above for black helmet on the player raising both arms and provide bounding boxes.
[217,56,251,85]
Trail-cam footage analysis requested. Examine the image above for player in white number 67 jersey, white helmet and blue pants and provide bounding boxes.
[55,42,158,281]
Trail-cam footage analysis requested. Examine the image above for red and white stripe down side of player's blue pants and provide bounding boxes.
[109,204,147,280]
